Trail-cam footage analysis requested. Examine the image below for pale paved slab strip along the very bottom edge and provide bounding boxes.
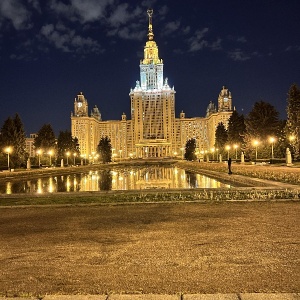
[0,293,300,300]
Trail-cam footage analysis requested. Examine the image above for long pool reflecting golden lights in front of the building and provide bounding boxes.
[0,166,230,194]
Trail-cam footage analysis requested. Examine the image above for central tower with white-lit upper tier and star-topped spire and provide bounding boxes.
[129,9,175,158]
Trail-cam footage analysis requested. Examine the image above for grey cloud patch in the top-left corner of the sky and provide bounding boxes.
[0,0,32,30]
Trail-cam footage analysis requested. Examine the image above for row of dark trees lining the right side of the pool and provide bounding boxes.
[185,84,300,160]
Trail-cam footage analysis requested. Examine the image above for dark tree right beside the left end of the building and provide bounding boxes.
[57,130,80,159]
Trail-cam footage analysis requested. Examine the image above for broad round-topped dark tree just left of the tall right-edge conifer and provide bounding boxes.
[245,101,280,158]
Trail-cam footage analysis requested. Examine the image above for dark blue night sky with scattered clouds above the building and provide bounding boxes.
[0,0,300,135]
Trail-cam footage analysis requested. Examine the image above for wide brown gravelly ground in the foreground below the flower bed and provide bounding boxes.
[0,202,300,296]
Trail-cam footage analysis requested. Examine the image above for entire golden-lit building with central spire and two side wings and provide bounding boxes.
[71,10,232,159]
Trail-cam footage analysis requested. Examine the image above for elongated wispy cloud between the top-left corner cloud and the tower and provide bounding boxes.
[40,23,103,53]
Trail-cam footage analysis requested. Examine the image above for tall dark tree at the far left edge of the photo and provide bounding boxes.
[0,114,27,167]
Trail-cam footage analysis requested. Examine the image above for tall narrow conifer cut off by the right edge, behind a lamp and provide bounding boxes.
[286,84,300,159]
